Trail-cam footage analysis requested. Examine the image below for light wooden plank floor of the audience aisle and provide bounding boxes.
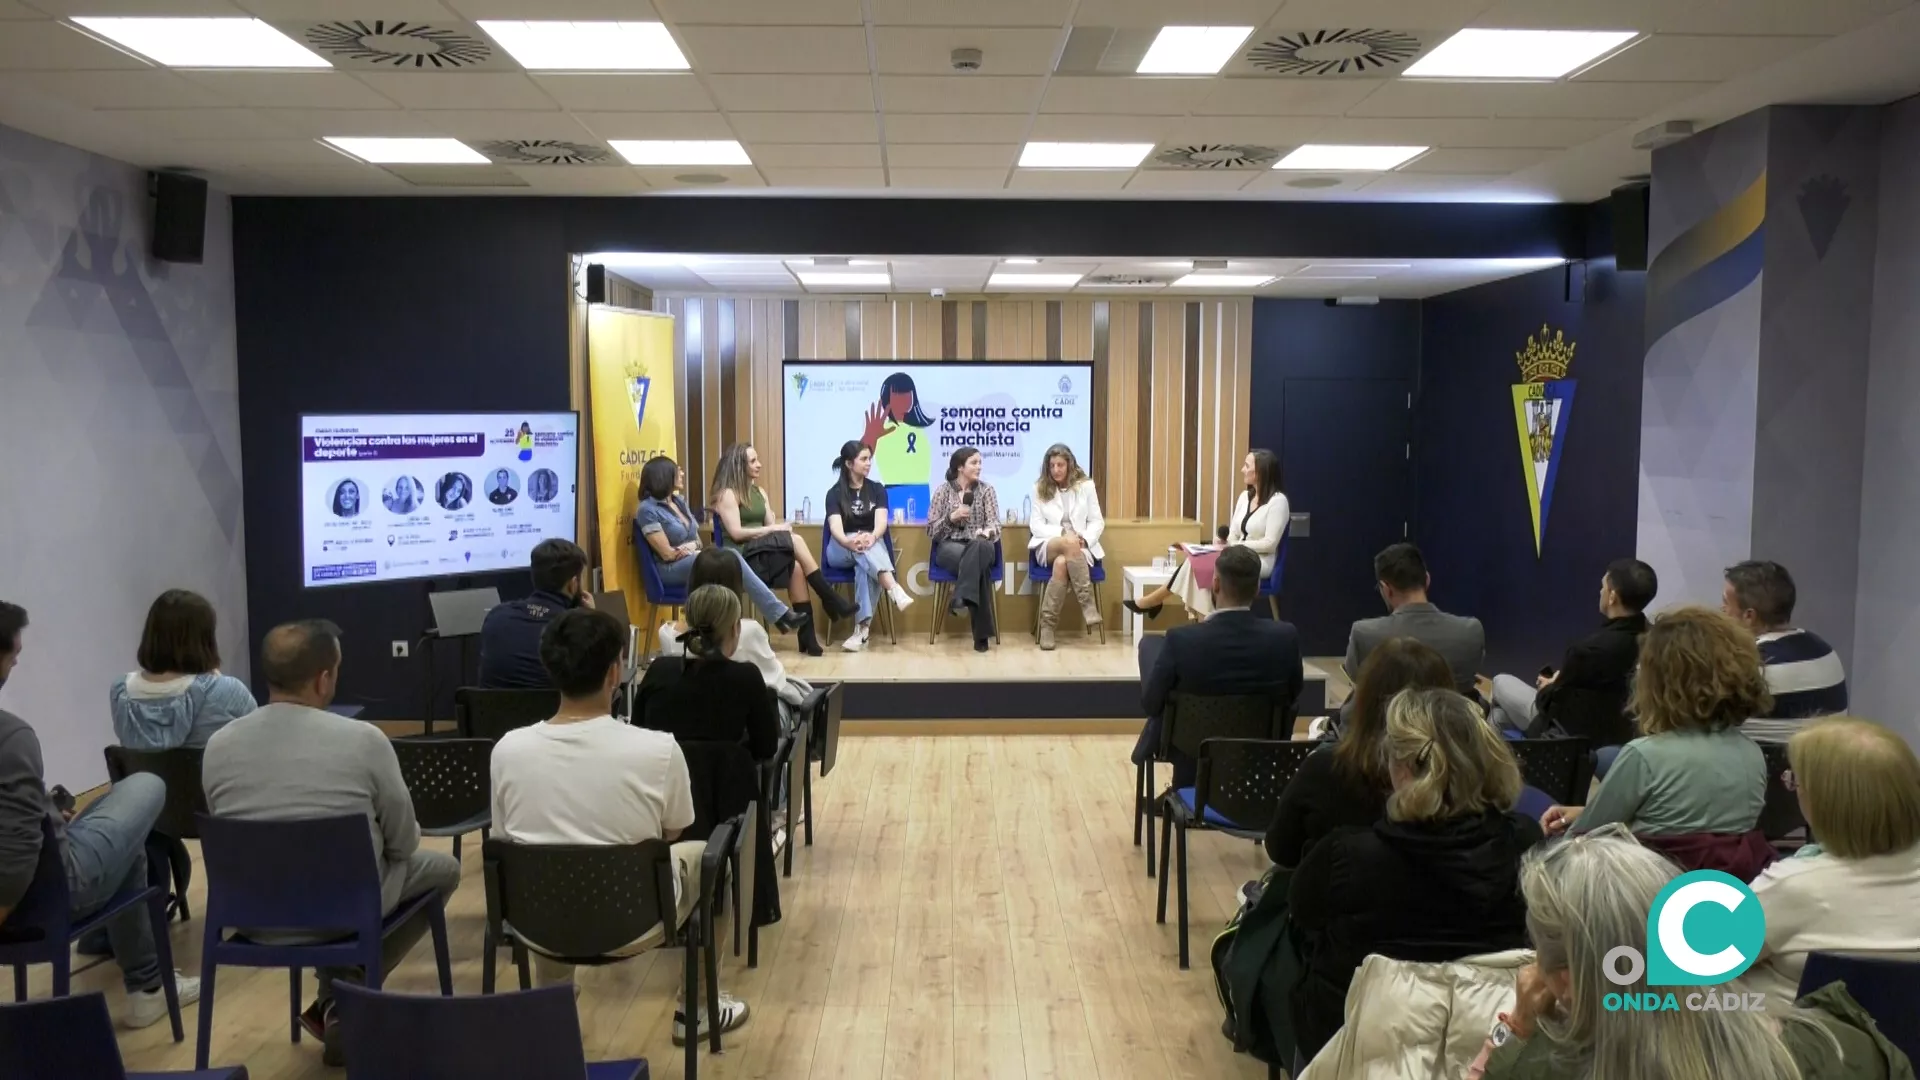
[67,736,1265,1080]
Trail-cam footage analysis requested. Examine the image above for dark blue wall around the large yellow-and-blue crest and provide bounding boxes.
[1413,259,1659,675]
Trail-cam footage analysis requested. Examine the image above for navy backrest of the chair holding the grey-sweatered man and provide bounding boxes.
[200,815,380,940]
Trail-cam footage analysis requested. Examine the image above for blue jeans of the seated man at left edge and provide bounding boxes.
[63,773,167,994]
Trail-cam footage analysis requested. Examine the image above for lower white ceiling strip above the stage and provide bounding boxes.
[586,252,1559,300]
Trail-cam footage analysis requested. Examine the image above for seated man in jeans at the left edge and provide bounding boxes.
[0,601,200,1028]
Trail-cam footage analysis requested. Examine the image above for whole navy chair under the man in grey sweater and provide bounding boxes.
[194,815,453,1068]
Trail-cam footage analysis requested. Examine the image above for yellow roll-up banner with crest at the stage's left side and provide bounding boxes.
[588,304,680,625]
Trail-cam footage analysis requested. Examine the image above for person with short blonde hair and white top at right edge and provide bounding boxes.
[1745,717,1920,1005]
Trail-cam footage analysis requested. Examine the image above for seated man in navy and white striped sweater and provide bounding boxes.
[1720,561,1847,742]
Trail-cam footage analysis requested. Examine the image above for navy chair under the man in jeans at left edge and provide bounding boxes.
[0,815,181,1037]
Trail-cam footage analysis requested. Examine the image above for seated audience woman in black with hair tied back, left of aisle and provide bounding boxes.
[634,584,780,761]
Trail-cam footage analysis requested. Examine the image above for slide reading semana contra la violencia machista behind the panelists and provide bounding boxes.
[783,359,1092,521]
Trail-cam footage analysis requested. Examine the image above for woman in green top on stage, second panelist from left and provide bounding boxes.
[707,442,856,655]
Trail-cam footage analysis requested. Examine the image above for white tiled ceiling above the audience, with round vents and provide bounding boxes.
[0,0,1920,202]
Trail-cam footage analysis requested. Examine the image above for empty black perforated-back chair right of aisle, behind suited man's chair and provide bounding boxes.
[1154,738,1319,970]
